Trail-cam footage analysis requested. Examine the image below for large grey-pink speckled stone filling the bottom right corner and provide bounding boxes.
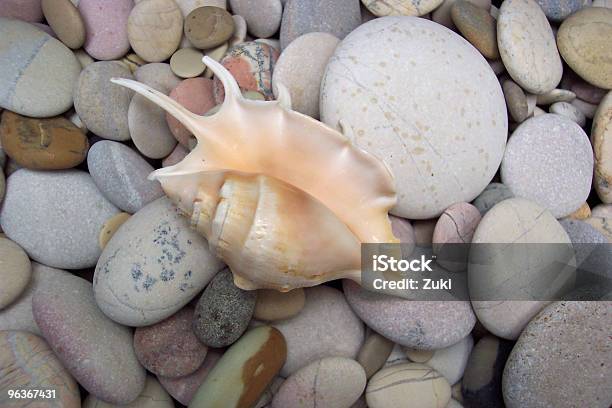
[503,302,612,408]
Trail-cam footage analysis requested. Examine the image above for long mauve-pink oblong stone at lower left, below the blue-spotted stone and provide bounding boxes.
[32,276,145,404]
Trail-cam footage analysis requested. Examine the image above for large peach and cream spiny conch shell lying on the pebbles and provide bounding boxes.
[112,57,398,291]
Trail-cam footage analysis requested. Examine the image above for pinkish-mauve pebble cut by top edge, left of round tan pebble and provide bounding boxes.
[78,0,134,61]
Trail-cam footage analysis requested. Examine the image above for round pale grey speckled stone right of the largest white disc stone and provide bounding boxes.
[501,114,593,218]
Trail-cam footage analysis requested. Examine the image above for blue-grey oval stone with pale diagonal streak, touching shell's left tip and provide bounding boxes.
[87,140,164,214]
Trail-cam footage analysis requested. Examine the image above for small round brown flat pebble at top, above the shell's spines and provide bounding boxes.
[184,7,234,49]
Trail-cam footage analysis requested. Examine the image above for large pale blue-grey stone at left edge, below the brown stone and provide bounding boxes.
[0,169,119,269]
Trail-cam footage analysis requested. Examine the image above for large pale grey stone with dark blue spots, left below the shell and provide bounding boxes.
[94,197,221,327]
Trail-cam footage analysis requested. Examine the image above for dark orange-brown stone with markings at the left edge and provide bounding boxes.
[0,110,89,170]
